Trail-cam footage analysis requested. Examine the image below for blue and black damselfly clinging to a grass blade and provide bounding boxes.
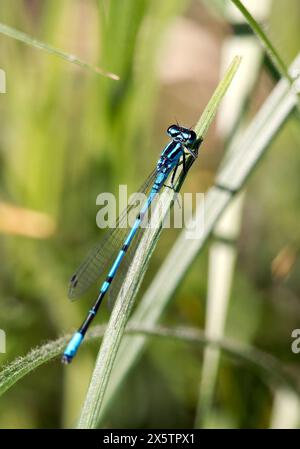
[62,125,201,363]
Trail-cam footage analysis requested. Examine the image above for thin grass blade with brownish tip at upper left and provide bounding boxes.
[0,23,119,81]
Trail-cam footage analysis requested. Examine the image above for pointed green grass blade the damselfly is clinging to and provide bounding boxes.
[78,57,241,428]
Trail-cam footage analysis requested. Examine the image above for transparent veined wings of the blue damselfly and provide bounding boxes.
[68,169,157,300]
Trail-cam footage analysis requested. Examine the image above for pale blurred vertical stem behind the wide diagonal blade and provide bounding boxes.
[194,7,273,428]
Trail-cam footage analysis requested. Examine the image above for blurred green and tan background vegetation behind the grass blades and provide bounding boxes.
[0,0,300,428]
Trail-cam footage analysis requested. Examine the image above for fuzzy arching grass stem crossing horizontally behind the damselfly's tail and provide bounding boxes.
[0,325,300,396]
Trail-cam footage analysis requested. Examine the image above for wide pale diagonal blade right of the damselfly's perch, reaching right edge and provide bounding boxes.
[96,52,300,424]
